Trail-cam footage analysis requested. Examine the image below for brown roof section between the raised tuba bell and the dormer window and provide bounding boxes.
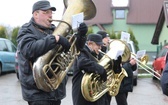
[85,0,113,25]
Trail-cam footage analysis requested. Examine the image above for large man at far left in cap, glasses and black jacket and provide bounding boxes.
[17,0,87,105]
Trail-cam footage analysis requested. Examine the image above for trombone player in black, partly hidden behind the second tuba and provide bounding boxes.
[97,30,137,105]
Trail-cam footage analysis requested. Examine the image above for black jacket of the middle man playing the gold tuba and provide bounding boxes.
[72,46,108,105]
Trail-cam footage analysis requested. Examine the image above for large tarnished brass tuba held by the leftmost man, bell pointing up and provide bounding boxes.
[33,0,96,92]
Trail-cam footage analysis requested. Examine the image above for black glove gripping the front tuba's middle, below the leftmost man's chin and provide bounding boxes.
[57,36,71,53]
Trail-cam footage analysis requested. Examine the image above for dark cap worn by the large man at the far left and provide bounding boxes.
[32,0,56,13]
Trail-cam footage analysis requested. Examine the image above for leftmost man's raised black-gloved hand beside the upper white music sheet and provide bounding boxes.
[76,23,88,50]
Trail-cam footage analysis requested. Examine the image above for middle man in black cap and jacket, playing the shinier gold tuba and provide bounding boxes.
[72,34,108,105]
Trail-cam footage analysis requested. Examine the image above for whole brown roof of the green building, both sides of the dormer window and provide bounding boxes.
[85,0,164,25]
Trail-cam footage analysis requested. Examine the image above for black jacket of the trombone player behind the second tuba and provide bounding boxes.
[119,62,137,93]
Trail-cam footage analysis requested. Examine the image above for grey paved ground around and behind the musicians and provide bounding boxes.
[0,73,168,105]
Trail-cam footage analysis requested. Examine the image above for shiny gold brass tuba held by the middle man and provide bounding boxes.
[81,40,131,102]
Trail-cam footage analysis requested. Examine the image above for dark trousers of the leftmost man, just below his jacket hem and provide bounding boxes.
[28,100,61,105]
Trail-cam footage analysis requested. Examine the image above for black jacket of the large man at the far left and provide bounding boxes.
[17,18,66,101]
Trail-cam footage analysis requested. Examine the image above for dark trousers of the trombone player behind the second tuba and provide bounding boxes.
[115,92,128,105]
